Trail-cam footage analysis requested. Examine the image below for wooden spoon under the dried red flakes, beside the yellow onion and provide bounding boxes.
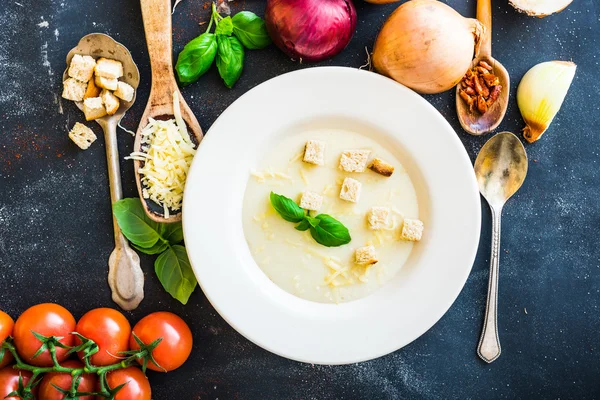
[456,0,510,135]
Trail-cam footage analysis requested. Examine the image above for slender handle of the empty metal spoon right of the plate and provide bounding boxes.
[477,206,502,363]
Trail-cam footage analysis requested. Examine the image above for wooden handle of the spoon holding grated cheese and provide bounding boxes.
[140,0,177,105]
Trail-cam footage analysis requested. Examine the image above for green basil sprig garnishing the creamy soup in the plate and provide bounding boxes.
[269,192,352,247]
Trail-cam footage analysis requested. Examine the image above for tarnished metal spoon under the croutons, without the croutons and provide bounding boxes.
[63,33,144,310]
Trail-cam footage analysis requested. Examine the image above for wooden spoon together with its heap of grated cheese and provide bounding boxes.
[135,0,203,223]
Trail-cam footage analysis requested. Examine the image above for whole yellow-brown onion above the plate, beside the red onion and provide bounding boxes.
[373,0,485,93]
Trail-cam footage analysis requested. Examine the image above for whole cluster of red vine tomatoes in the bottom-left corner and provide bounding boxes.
[0,303,192,400]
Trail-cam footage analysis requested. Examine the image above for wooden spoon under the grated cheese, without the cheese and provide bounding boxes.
[134,0,203,223]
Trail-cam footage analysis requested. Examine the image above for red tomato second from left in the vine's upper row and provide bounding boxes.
[14,303,75,367]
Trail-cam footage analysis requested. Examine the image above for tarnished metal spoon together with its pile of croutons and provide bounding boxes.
[63,33,144,310]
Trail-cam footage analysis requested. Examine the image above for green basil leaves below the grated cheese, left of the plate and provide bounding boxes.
[113,198,197,304]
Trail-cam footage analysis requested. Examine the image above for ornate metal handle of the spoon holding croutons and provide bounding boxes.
[101,118,144,310]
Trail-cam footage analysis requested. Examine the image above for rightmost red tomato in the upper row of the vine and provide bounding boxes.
[129,312,192,372]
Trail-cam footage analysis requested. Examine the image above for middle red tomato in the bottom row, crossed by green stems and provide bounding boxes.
[38,360,98,400]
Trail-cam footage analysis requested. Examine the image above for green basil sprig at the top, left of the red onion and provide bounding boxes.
[175,3,271,88]
